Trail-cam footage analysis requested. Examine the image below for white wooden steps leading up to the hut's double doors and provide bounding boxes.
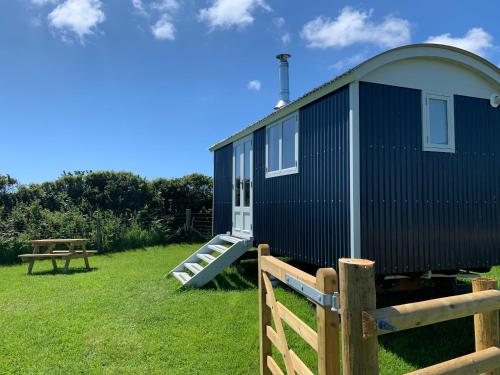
[170,234,252,288]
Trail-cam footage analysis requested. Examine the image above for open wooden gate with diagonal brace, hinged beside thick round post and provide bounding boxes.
[259,245,340,375]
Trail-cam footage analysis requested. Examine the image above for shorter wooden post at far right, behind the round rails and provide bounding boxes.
[472,278,500,375]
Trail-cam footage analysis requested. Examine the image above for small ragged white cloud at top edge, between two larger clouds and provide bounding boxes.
[132,0,180,40]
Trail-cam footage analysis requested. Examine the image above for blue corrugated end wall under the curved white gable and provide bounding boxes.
[360,82,500,274]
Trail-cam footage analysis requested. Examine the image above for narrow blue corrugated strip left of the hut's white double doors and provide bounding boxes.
[213,144,233,234]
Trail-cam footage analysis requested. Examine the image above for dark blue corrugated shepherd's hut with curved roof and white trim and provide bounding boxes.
[211,44,500,275]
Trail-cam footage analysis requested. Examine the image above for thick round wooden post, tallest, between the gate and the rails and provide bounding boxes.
[339,258,378,375]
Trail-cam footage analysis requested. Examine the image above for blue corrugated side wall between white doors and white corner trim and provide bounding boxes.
[253,87,349,267]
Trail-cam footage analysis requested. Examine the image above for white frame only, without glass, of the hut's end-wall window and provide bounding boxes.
[422,91,455,153]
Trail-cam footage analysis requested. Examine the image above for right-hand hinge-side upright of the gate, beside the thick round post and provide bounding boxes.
[316,268,340,375]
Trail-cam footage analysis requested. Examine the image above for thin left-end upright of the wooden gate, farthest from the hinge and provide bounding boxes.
[258,245,273,375]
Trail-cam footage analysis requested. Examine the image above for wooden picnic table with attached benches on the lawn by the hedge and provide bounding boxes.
[19,238,97,275]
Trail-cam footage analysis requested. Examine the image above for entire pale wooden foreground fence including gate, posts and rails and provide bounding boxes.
[259,245,500,375]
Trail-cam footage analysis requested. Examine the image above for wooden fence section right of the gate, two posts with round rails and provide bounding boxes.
[339,259,500,375]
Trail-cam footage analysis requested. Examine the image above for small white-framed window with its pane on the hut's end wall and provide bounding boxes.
[422,92,455,152]
